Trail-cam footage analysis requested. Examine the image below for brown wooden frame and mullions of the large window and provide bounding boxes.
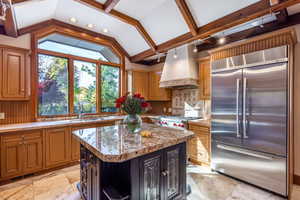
[36,48,124,118]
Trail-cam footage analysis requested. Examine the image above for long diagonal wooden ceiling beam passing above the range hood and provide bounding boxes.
[130,0,300,62]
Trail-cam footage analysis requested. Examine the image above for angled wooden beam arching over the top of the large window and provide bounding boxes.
[18,19,129,57]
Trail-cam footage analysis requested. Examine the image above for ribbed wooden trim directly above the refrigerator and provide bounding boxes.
[209,28,296,60]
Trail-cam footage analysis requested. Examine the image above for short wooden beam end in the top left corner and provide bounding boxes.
[3,0,18,37]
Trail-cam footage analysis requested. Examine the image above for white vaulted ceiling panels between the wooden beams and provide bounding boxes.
[14,0,300,56]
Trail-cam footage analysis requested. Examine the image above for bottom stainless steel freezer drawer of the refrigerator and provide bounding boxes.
[212,142,287,196]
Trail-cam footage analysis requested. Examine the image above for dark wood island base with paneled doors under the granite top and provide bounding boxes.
[77,142,186,200]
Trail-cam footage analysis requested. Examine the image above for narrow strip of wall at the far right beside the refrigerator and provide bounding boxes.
[294,25,300,176]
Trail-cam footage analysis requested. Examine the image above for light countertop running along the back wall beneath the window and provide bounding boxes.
[0,115,162,134]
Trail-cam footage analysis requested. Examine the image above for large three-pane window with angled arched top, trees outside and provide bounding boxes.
[37,33,121,117]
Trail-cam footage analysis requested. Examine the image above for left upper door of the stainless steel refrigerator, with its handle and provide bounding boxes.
[211,70,242,146]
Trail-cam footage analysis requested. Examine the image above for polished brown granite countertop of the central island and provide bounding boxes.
[72,123,194,162]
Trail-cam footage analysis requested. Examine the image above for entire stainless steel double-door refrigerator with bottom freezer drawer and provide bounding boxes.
[211,46,288,196]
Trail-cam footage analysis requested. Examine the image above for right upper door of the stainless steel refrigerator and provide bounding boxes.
[242,63,287,156]
